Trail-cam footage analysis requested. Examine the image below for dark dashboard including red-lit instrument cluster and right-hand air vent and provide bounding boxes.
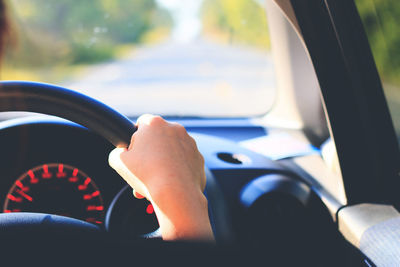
[0,116,331,243]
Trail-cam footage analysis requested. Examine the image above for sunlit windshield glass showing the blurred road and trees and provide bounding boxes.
[2,0,275,117]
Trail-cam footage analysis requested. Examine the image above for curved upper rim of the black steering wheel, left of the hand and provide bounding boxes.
[0,81,136,147]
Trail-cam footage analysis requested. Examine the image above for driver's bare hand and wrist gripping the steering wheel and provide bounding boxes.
[109,114,214,240]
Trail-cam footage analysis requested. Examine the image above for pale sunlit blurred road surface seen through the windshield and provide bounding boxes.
[64,41,275,116]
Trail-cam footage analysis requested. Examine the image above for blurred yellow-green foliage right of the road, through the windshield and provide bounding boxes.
[202,0,270,48]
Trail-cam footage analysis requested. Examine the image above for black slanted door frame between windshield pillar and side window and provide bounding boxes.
[275,0,400,206]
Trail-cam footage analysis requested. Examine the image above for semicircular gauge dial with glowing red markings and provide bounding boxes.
[3,163,104,224]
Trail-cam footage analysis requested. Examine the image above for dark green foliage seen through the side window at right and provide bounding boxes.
[356,0,400,86]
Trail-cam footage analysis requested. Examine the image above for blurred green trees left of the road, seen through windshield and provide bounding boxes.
[6,0,172,67]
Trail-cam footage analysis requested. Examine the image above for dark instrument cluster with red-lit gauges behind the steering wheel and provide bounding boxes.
[0,118,158,236]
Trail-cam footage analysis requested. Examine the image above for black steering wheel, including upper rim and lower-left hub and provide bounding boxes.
[0,81,225,243]
